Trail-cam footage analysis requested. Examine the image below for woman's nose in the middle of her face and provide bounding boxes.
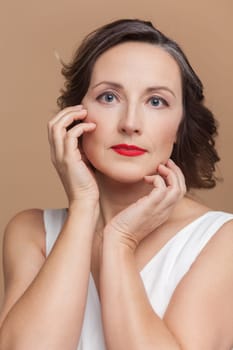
[119,105,142,135]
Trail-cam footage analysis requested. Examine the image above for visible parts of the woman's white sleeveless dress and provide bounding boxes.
[44,209,233,350]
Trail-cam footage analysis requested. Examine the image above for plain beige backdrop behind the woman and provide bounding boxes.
[0,0,233,304]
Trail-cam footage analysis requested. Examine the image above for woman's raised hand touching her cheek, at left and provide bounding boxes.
[48,105,99,205]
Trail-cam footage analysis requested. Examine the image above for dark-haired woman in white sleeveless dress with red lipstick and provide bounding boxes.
[0,20,233,350]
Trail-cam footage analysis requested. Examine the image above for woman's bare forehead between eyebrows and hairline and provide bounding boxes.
[91,42,181,93]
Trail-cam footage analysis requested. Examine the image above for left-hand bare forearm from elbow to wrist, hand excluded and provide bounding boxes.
[0,202,95,350]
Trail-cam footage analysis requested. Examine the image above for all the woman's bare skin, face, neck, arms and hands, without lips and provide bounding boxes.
[0,42,233,350]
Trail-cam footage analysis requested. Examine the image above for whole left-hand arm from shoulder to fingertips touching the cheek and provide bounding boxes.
[0,106,99,350]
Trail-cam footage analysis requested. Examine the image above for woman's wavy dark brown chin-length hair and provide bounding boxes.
[57,19,220,189]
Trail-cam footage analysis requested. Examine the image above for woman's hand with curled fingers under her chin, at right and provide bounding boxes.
[105,159,186,250]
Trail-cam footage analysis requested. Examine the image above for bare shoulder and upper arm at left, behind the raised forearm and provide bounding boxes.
[0,209,45,321]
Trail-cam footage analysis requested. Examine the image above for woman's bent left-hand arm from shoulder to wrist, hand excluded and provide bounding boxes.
[0,203,94,350]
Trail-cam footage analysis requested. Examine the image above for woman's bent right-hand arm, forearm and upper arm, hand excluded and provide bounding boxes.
[101,222,233,350]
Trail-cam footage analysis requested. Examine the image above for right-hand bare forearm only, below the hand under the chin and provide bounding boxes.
[101,235,180,350]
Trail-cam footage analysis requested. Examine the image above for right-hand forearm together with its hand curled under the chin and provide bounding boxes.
[100,162,185,350]
